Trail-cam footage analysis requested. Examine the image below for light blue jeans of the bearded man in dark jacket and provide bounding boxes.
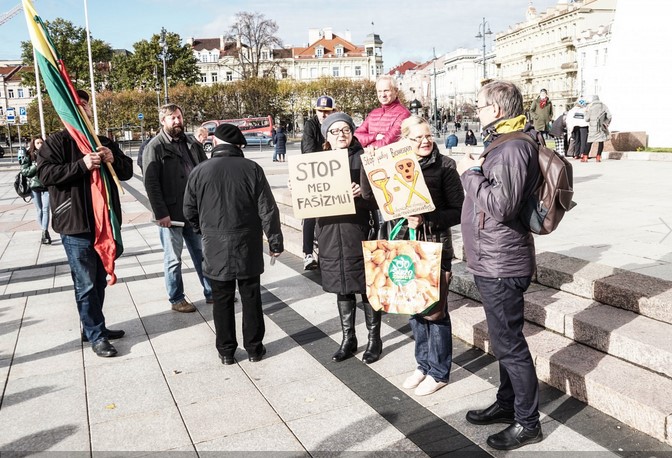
[159,225,212,304]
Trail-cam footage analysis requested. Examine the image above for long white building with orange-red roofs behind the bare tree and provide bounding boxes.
[188,28,383,85]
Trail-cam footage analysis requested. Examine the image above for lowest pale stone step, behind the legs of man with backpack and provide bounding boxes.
[449,293,672,445]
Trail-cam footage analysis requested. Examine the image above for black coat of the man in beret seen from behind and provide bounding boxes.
[184,145,284,281]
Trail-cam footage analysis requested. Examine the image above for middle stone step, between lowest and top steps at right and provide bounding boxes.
[450,262,672,377]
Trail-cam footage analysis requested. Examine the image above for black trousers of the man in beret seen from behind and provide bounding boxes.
[210,275,266,356]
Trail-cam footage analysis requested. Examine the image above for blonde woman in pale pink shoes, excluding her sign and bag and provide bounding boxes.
[362,115,464,396]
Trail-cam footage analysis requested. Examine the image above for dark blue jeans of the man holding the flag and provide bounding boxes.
[61,234,107,344]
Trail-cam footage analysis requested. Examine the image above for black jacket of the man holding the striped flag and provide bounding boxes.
[37,130,133,235]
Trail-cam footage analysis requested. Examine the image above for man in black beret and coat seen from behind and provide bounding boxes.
[184,124,284,365]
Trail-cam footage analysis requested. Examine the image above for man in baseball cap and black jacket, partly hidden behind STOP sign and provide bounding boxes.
[301,95,334,270]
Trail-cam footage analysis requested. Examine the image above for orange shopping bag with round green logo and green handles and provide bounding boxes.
[362,219,442,315]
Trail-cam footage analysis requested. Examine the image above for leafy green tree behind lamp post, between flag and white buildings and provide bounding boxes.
[109,32,200,91]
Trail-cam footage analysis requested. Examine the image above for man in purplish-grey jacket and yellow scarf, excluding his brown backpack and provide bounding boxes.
[457,81,543,450]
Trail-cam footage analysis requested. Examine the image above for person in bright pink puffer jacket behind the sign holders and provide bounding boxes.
[355,75,411,148]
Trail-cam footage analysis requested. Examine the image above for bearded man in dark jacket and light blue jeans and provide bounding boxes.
[143,104,212,313]
